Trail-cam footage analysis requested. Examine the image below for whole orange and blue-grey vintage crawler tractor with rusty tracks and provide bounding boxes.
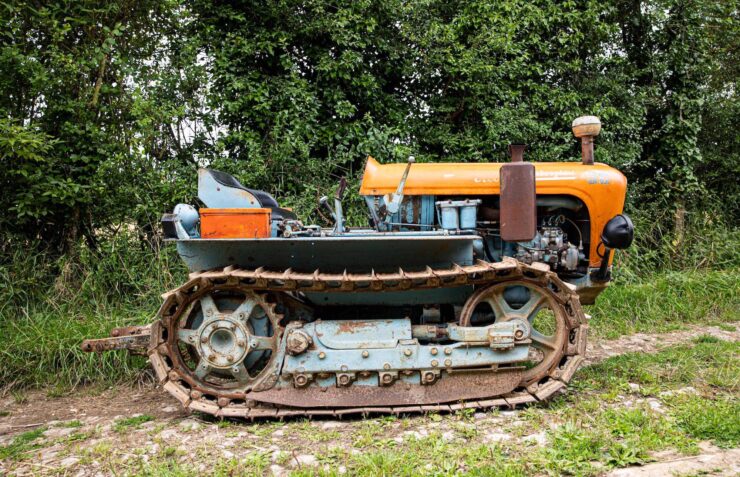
[82,116,633,418]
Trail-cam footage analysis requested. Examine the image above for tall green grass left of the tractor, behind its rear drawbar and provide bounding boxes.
[0,234,186,392]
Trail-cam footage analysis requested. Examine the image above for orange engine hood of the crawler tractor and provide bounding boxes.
[360,157,627,266]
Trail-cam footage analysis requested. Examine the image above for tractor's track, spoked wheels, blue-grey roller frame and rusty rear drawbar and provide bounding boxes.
[83,259,588,417]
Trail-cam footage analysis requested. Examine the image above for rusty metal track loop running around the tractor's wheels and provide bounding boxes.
[143,259,588,418]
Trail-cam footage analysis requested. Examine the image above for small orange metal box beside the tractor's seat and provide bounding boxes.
[200,208,270,238]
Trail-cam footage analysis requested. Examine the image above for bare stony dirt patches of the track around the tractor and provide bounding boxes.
[0,326,740,477]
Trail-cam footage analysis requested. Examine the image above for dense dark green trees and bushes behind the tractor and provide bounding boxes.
[0,0,740,255]
